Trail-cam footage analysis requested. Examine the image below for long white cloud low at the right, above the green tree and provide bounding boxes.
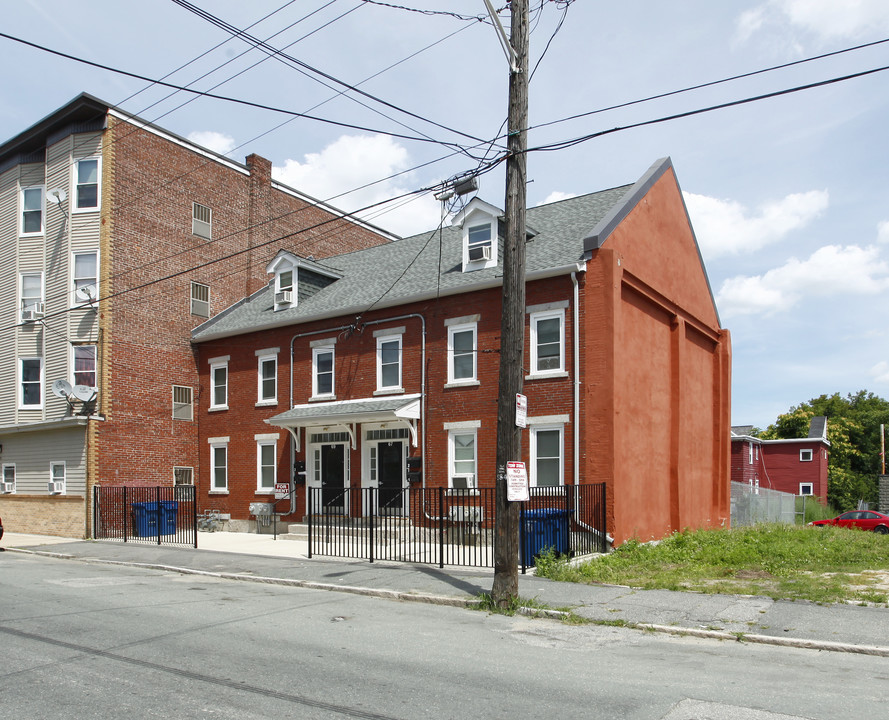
[717,245,889,317]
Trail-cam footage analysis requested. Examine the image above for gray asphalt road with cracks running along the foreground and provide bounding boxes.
[0,553,889,720]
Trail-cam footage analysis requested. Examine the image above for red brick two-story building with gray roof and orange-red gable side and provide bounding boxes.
[192,160,731,543]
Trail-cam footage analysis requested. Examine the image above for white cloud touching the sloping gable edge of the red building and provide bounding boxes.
[684,190,829,259]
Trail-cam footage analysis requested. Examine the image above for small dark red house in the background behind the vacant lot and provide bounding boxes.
[732,417,830,504]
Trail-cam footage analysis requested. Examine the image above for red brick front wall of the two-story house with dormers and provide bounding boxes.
[198,278,587,521]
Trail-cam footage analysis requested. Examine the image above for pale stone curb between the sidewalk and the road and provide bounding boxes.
[6,548,889,657]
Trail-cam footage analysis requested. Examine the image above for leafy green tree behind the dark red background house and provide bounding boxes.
[759,390,889,511]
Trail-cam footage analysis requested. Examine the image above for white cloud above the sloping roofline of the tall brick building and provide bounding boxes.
[272,135,441,235]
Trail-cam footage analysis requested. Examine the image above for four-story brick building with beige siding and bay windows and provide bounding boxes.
[0,95,392,536]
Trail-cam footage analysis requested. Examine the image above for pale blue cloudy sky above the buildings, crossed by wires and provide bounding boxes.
[0,0,889,427]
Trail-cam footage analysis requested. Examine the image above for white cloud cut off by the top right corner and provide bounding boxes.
[735,0,889,42]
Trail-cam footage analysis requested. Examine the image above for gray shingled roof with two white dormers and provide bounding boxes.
[192,179,633,342]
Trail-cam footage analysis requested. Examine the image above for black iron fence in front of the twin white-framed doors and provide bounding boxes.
[307,484,607,572]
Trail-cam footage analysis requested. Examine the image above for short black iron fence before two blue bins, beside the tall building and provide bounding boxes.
[93,485,198,547]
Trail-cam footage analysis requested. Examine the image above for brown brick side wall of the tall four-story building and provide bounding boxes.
[91,117,384,492]
